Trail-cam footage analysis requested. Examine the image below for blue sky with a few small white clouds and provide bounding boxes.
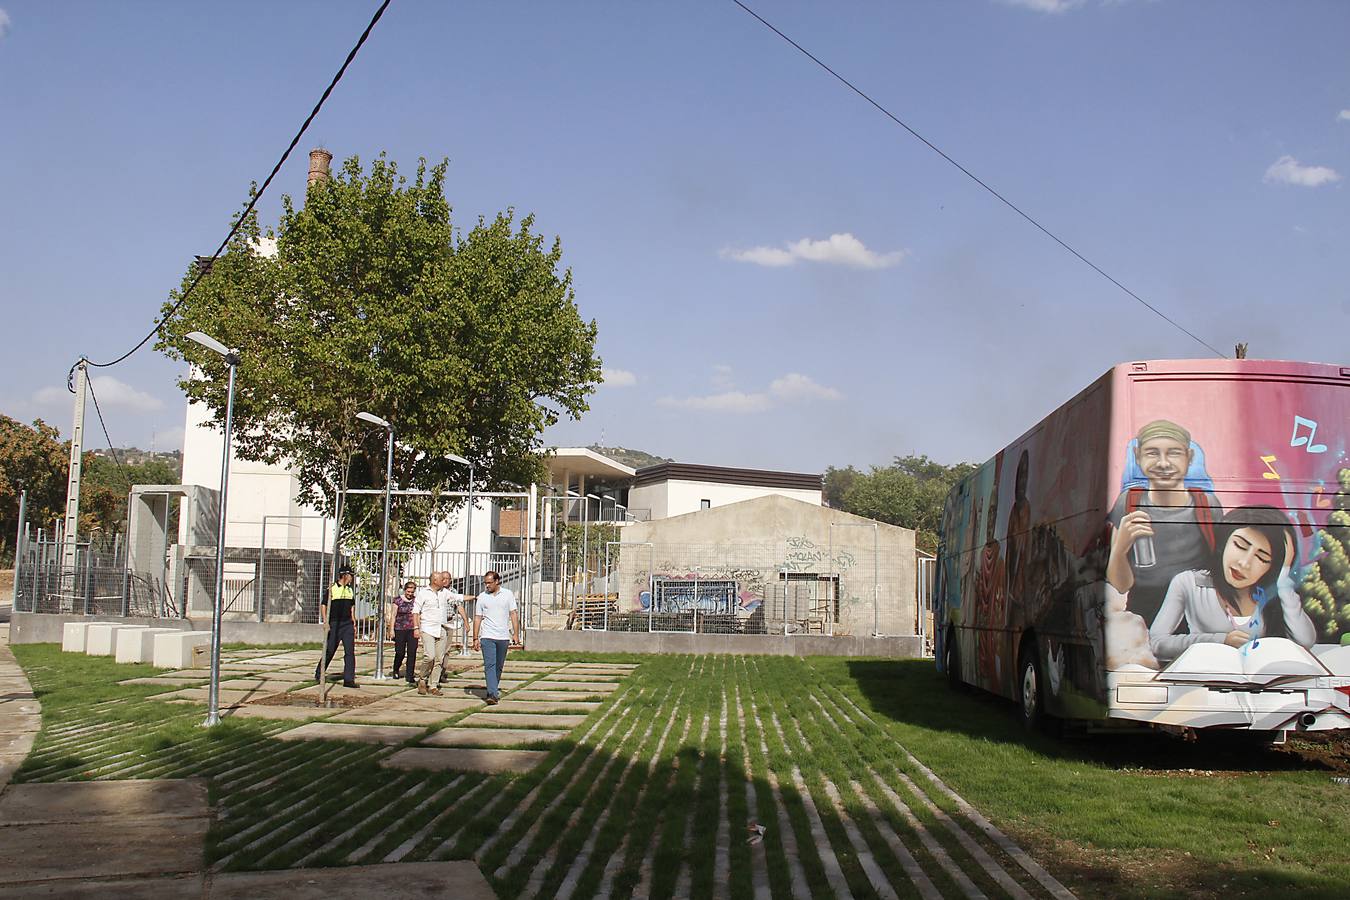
[0,0,1350,472]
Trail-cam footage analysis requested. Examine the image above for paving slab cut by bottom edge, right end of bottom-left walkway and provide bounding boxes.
[207,860,497,900]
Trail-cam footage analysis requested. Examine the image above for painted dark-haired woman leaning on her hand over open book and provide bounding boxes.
[1149,506,1316,664]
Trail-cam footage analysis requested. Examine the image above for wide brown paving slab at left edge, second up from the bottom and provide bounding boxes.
[0,825,211,896]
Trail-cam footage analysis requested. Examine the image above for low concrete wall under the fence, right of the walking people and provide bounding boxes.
[525,629,919,658]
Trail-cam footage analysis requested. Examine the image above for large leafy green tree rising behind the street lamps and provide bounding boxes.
[158,155,599,545]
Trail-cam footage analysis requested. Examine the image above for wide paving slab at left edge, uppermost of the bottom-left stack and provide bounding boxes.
[0,779,211,826]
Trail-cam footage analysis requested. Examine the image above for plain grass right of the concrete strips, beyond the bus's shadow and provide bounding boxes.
[810,658,1350,897]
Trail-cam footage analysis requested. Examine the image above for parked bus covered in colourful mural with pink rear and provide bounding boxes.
[933,359,1350,741]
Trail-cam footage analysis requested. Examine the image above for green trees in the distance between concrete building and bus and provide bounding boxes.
[825,455,976,552]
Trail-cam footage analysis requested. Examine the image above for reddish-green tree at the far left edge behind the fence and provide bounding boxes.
[0,416,70,565]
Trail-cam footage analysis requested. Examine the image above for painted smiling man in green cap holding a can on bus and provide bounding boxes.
[1106,418,1223,625]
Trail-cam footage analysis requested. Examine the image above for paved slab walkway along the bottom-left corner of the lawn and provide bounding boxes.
[0,622,495,900]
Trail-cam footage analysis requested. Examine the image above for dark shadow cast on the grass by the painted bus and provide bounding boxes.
[845,660,1350,775]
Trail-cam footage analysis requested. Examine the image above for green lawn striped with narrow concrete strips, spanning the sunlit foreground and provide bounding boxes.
[14,645,1350,897]
